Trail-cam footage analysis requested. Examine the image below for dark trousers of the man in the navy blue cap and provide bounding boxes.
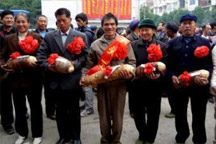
[174,86,209,144]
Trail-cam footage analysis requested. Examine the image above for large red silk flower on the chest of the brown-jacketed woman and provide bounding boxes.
[19,36,39,54]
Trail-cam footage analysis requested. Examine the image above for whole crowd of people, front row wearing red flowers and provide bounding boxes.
[0,8,216,144]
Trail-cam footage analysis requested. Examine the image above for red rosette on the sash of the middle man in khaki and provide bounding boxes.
[113,41,128,60]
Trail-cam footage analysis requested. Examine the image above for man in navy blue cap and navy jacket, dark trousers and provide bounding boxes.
[167,14,213,144]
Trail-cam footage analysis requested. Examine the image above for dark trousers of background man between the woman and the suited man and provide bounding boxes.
[44,84,56,116]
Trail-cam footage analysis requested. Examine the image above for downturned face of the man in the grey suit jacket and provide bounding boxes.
[56,14,71,33]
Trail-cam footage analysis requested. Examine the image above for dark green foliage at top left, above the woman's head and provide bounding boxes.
[0,0,41,27]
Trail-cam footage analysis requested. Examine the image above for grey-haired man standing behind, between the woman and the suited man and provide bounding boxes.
[34,15,56,120]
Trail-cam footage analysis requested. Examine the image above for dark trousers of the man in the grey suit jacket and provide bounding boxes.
[51,87,81,140]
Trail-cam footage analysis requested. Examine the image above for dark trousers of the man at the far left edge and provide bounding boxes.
[0,78,14,129]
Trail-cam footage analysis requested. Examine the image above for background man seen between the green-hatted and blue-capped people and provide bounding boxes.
[157,22,168,43]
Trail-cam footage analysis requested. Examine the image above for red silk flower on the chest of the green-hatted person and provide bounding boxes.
[147,44,163,62]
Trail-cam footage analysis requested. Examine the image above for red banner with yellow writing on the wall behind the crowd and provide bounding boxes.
[82,0,132,20]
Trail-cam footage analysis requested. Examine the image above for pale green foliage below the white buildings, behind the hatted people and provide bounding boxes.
[140,6,216,26]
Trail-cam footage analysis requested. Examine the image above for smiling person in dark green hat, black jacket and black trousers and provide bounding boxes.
[129,19,167,144]
